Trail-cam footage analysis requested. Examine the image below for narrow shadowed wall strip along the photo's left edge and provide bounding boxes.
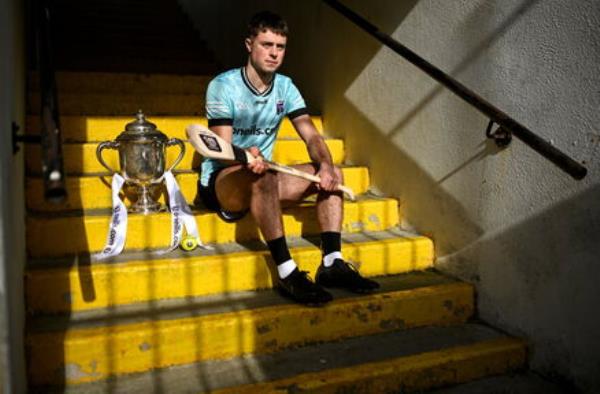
[0,0,27,393]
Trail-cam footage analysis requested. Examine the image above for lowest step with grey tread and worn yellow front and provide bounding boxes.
[34,323,524,394]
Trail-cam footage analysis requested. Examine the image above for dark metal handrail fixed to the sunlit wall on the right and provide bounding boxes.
[323,0,587,180]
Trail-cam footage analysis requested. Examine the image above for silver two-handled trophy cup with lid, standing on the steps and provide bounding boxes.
[96,110,185,215]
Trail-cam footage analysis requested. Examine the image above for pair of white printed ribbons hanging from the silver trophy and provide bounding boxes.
[93,171,212,260]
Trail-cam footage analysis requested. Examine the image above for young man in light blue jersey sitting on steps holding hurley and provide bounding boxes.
[198,12,379,304]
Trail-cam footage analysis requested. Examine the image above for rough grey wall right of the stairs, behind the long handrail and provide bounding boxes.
[180,0,600,392]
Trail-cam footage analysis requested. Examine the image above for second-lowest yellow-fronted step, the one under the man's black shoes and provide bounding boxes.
[26,273,478,386]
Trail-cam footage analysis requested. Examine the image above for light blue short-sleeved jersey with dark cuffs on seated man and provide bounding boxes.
[200,67,308,186]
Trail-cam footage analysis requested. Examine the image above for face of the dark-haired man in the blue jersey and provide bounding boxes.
[246,30,287,74]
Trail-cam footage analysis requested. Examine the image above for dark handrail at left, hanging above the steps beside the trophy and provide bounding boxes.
[33,0,67,203]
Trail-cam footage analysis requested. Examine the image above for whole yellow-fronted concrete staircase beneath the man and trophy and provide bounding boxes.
[25,0,526,393]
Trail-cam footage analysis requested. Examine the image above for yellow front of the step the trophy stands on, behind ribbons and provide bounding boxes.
[26,196,399,257]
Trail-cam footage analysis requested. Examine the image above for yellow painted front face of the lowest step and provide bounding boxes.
[213,337,527,394]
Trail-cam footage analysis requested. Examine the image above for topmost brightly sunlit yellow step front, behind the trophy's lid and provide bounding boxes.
[26,114,323,142]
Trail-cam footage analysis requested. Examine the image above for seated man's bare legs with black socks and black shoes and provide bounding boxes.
[217,164,378,304]
